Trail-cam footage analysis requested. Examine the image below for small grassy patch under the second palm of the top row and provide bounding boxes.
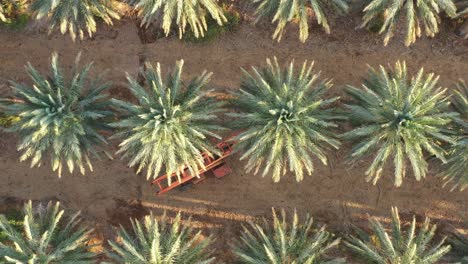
[182,9,240,43]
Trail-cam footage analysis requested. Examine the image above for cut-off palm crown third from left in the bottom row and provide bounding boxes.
[234,209,343,264]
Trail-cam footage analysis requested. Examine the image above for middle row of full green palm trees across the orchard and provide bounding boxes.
[0,53,468,189]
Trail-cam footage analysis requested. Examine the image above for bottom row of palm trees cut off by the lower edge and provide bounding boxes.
[0,201,468,264]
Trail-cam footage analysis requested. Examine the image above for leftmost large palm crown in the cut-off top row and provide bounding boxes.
[31,0,119,41]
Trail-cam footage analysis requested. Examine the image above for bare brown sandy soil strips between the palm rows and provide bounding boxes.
[0,14,468,263]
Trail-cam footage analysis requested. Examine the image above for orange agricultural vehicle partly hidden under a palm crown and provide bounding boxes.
[151,137,234,195]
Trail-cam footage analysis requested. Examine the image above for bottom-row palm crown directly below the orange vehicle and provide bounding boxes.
[109,213,214,264]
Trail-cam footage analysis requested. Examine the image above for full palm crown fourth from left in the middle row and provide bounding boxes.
[343,62,456,186]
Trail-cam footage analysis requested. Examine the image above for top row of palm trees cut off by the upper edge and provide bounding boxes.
[0,0,468,46]
